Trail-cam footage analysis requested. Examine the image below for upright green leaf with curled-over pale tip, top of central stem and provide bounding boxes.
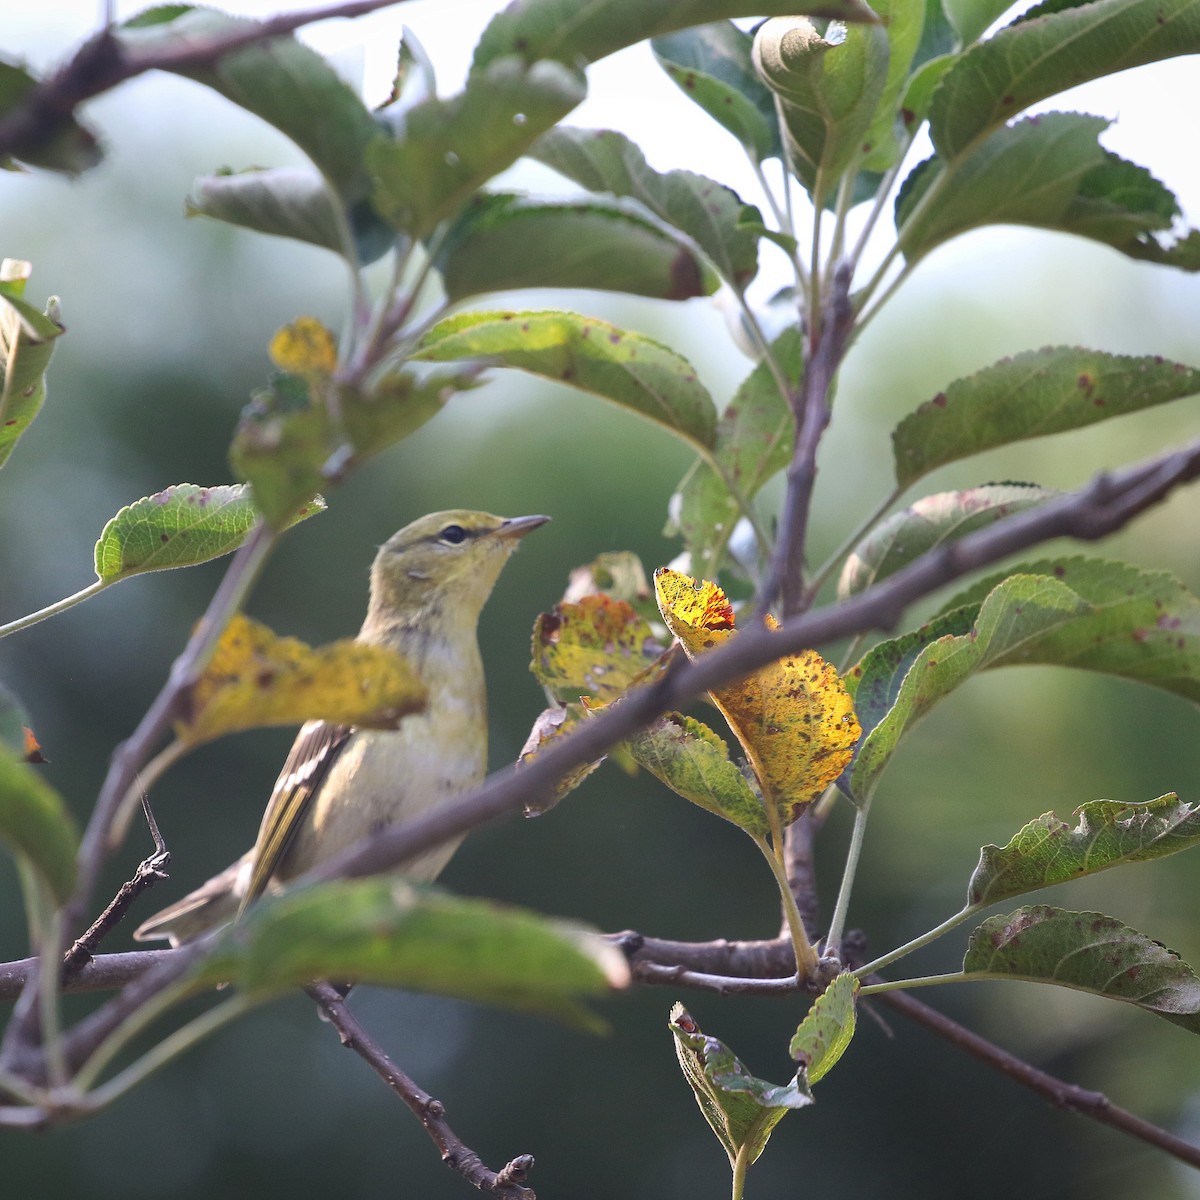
[754,17,889,204]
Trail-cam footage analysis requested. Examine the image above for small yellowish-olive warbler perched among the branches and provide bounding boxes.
[133,509,550,946]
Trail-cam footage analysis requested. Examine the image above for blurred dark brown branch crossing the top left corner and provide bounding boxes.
[0,0,400,166]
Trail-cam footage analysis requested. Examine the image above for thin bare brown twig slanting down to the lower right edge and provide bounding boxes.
[876,991,1200,1168]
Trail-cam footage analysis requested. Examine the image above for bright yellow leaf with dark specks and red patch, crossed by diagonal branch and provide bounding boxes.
[654,568,862,824]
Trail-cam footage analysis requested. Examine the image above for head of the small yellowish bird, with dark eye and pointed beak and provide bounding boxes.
[367,509,550,626]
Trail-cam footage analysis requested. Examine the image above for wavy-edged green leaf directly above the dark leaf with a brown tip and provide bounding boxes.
[529,127,762,292]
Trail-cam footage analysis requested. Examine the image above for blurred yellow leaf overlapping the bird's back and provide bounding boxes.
[175,613,426,744]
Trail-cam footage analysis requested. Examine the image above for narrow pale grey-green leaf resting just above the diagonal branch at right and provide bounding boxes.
[838,484,1060,600]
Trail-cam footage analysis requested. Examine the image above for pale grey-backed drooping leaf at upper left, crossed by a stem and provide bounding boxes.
[186,167,395,263]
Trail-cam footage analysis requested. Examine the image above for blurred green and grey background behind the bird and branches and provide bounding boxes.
[0,0,1200,1200]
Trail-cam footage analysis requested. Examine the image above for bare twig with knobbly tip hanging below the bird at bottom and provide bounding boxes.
[305,983,536,1200]
